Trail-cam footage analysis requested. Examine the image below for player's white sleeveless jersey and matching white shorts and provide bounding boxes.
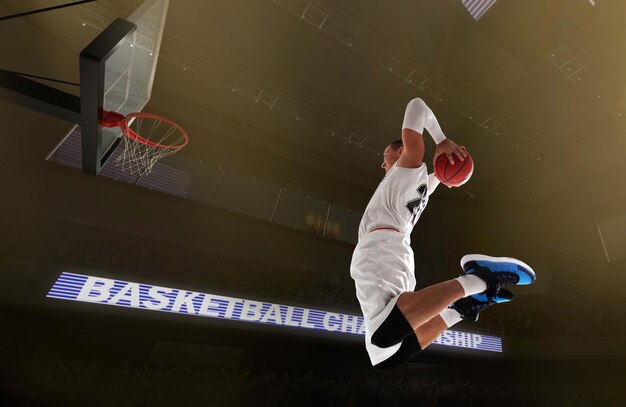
[350,163,439,365]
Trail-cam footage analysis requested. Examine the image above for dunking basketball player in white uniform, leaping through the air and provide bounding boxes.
[350,98,535,370]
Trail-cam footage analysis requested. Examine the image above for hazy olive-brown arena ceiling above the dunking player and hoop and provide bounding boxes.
[2,0,626,209]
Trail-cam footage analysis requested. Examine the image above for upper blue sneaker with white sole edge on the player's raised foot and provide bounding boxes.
[461,254,537,300]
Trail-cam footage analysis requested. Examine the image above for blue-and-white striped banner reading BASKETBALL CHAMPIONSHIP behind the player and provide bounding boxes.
[47,273,502,352]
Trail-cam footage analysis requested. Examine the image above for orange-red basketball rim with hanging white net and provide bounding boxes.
[100,111,189,176]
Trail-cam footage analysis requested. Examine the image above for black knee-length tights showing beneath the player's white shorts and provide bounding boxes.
[372,305,422,370]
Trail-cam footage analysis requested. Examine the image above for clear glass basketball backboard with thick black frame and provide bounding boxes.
[48,0,169,175]
